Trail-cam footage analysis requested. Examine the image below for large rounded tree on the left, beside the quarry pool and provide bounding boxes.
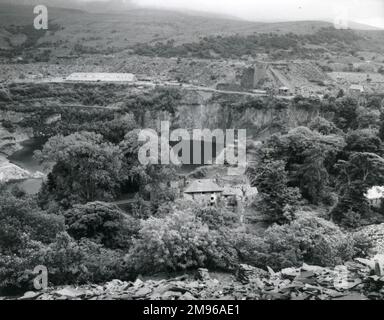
[36,132,123,206]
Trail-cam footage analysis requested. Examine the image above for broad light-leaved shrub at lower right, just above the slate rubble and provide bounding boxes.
[236,213,370,270]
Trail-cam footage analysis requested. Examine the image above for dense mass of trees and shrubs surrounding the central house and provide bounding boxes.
[0,90,384,296]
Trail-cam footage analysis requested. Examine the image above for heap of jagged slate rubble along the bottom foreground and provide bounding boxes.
[1,255,384,300]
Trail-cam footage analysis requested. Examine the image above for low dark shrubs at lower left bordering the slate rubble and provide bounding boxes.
[0,232,133,294]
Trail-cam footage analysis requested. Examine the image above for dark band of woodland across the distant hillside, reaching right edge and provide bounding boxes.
[134,24,384,60]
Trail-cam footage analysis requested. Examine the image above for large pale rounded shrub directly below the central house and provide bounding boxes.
[127,211,237,272]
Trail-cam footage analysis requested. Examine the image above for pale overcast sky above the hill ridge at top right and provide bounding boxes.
[129,0,384,28]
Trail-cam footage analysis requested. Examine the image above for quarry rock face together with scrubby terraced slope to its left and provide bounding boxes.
[0,83,318,144]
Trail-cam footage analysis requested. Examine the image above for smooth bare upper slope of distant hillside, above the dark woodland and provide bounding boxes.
[0,4,329,53]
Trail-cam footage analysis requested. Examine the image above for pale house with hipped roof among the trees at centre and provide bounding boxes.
[184,179,224,205]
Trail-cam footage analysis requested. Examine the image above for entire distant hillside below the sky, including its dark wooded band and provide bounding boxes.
[0,0,384,58]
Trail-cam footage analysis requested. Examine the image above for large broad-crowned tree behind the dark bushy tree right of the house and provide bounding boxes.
[255,127,344,204]
